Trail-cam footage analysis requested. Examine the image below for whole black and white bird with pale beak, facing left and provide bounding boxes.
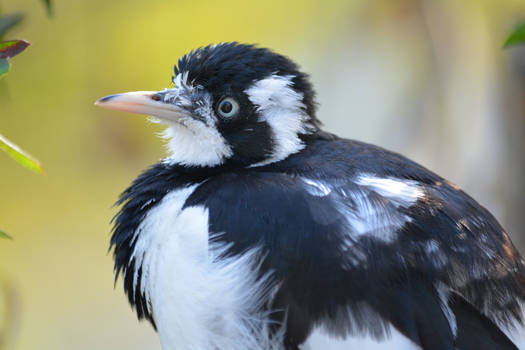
[97,43,525,350]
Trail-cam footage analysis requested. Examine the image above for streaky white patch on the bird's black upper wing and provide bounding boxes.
[294,174,422,268]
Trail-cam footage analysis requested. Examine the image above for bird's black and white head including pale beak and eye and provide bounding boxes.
[96,43,319,167]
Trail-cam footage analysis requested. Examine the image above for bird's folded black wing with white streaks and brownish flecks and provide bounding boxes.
[186,137,525,349]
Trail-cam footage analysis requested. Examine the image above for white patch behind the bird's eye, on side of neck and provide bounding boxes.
[244,74,313,166]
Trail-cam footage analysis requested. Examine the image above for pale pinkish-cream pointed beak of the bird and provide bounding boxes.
[95,91,184,121]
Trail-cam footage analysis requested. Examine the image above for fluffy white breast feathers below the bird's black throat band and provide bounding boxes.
[130,185,282,350]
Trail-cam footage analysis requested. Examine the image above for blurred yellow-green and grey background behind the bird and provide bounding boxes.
[0,0,525,350]
